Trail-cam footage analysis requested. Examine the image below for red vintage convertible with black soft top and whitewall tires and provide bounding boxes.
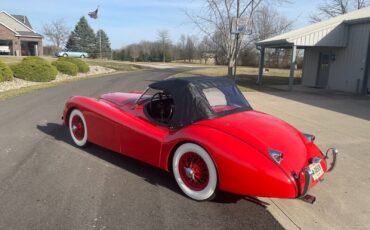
[63,77,337,203]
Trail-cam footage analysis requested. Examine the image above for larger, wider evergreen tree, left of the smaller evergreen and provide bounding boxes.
[66,17,97,56]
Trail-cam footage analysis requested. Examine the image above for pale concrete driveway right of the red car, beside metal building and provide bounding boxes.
[246,90,370,229]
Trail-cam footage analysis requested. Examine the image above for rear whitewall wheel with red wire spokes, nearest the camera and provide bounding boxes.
[172,143,217,201]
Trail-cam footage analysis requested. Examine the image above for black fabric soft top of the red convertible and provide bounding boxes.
[149,77,251,127]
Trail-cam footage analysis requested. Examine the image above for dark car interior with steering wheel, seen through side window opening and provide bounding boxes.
[145,92,175,124]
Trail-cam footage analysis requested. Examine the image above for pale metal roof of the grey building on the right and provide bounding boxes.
[256,7,370,48]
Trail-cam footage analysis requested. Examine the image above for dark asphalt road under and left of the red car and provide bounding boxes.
[0,69,282,229]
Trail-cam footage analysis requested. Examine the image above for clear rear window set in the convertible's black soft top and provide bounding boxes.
[202,85,250,114]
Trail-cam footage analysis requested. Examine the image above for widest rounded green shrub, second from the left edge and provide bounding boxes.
[11,57,58,82]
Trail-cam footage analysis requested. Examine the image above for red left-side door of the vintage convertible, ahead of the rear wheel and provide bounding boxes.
[121,106,169,167]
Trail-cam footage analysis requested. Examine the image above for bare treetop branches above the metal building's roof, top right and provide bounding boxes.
[310,0,369,22]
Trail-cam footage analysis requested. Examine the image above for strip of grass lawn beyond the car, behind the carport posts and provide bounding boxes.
[173,66,302,91]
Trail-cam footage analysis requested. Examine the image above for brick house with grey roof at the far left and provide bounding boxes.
[0,11,43,56]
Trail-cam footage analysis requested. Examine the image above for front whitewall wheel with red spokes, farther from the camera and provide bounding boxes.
[69,109,88,147]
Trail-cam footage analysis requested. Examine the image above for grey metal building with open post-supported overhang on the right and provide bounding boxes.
[256,7,370,93]
